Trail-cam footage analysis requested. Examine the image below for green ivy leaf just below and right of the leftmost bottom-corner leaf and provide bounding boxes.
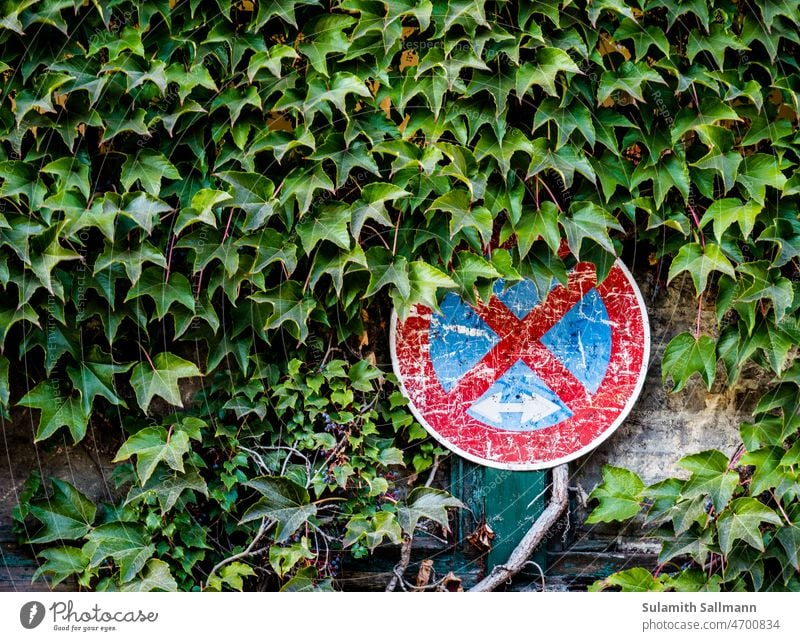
[83,521,156,583]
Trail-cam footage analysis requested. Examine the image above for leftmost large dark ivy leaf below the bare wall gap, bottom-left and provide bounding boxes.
[29,479,97,543]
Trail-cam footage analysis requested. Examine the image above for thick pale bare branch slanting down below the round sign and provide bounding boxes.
[470,463,569,592]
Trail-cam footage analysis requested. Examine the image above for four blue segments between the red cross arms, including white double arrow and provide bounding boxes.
[429,280,612,431]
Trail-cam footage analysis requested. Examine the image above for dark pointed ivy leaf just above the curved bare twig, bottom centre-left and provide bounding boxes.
[241,476,317,543]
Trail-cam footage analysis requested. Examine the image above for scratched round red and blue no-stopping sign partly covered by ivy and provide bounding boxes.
[391,261,650,470]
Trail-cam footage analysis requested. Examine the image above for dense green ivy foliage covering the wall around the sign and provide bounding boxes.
[0,0,800,590]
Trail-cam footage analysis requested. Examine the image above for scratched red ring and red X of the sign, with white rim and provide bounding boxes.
[391,261,650,470]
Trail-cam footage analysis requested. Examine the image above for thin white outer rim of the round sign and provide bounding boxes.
[389,258,650,472]
